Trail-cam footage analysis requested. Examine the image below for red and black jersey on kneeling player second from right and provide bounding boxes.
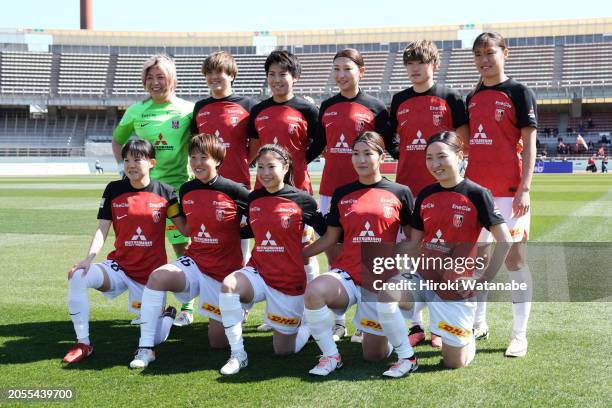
[327,178,414,285]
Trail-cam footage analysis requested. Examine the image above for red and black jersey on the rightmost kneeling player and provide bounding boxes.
[410,179,504,299]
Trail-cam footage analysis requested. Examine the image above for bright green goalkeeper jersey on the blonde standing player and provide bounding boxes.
[113,97,193,191]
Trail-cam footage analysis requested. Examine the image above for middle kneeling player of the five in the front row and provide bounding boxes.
[219,144,324,375]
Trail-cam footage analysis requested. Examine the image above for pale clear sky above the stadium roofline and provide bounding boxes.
[0,0,612,32]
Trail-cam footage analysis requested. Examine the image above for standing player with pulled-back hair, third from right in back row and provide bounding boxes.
[306,48,392,341]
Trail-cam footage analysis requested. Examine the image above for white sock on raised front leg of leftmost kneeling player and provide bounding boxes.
[68,265,104,344]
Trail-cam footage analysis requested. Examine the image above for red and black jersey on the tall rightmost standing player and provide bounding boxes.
[466,78,538,197]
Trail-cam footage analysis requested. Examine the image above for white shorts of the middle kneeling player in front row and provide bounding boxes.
[239,266,304,335]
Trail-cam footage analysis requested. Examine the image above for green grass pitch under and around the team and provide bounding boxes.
[0,174,612,407]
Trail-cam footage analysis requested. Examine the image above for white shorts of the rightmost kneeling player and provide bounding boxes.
[401,274,476,347]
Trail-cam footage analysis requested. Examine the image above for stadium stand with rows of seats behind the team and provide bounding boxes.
[0,19,612,154]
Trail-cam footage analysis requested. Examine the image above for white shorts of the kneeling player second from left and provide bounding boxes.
[172,256,222,322]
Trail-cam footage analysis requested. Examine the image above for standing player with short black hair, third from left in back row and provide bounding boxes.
[249,51,319,331]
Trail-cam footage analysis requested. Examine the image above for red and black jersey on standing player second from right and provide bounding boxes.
[389,84,468,194]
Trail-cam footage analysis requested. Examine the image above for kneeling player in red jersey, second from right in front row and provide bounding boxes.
[304,132,413,376]
